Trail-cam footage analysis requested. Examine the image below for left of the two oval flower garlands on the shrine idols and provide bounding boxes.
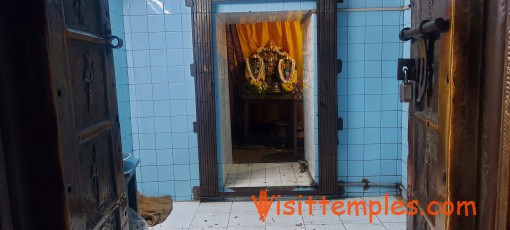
[245,54,267,93]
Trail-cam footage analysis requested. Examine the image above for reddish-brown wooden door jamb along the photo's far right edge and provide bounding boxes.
[476,0,510,229]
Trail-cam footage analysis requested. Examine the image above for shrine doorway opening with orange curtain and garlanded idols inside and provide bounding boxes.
[213,11,318,191]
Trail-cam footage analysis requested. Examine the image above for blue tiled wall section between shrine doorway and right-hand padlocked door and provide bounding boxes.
[338,0,403,196]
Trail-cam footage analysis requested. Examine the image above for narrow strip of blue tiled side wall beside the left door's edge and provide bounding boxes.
[109,0,133,156]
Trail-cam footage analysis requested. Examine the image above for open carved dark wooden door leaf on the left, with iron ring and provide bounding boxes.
[46,0,128,229]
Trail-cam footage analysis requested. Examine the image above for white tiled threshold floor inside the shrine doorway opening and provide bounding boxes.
[225,162,313,188]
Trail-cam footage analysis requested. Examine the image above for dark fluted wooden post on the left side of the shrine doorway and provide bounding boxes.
[191,0,219,197]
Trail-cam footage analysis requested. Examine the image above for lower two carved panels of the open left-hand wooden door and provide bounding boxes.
[66,29,125,229]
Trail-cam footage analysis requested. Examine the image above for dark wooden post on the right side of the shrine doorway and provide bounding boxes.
[316,0,339,195]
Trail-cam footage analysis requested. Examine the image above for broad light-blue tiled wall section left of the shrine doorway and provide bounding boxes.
[124,0,199,200]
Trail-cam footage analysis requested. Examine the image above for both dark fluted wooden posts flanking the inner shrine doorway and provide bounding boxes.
[191,0,338,197]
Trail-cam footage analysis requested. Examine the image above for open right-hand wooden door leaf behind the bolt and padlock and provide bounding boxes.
[407,0,451,229]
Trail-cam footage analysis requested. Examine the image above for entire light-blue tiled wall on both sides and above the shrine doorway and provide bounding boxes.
[111,0,407,200]
